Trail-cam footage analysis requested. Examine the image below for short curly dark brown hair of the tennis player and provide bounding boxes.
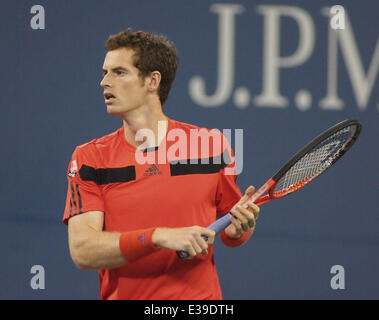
[105,28,178,105]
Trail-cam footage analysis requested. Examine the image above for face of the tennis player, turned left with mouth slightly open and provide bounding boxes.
[100,48,148,116]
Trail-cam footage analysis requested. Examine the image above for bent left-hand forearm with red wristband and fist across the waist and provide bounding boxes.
[69,226,218,270]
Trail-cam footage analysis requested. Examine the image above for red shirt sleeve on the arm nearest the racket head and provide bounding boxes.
[216,137,242,217]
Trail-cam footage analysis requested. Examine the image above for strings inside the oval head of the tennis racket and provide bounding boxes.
[273,126,356,197]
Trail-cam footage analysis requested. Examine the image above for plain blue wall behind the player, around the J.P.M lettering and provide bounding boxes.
[0,0,379,299]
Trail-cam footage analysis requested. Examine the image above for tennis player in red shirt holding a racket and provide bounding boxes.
[63,29,259,300]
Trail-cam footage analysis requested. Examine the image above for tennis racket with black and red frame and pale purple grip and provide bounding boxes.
[178,120,362,259]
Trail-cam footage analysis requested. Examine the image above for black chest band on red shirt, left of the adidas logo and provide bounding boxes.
[79,164,136,185]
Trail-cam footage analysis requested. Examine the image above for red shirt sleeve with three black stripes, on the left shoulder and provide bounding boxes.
[62,147,105,225]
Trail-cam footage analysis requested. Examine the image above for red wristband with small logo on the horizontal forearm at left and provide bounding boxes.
[119,228,159,263]
